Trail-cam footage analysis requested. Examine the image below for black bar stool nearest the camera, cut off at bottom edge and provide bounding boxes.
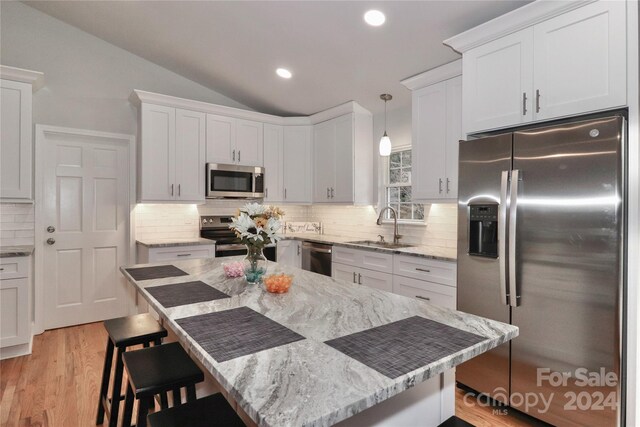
[147,393,244,427]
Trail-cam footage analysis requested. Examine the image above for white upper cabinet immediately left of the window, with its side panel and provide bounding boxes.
[313,110,373,204]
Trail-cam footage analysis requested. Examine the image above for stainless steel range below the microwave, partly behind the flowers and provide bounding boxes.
[200,215,276,261]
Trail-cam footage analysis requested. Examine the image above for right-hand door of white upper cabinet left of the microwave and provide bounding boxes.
[175,109,206,202]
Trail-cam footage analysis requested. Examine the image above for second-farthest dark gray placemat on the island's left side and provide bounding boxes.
[144,280,231,308]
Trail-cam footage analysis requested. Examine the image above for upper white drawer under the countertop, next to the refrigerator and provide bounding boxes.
[393,255,456,286]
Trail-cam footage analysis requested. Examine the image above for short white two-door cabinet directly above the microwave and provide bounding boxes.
[206,114,264,166]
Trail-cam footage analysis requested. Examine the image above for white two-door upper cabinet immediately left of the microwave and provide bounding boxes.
[138,103,205,203]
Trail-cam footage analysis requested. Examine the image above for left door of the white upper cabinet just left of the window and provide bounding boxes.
[313,120,336,203]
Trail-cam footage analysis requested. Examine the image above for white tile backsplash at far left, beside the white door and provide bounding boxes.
[0,203,35,246]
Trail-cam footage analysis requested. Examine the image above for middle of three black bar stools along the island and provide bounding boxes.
[122,342,204,427]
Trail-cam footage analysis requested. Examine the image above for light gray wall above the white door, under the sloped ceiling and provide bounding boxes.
[0,1,249,135]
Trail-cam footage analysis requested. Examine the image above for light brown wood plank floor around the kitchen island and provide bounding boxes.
[0,323,531,427]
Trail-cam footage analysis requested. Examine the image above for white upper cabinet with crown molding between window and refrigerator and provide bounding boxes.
[402,60,462,202]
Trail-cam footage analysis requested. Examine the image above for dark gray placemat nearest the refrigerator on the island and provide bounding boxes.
[325,316,486,378]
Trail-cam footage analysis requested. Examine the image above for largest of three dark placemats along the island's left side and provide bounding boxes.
[176,307,305,362]
